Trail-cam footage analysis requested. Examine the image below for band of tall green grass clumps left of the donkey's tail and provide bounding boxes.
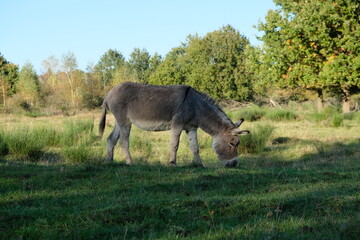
[0,119,98,163]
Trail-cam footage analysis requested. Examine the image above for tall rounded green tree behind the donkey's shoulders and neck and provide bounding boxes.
[185,25,250,100]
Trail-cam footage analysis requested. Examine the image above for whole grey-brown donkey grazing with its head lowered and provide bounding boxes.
[99,82,250,167]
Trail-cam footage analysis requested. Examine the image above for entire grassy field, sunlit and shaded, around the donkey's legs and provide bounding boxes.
[0,106,360,239]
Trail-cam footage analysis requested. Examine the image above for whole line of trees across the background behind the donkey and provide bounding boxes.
[0,0,360,112]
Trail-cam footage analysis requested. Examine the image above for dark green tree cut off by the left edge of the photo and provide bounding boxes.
[0,53,19,106]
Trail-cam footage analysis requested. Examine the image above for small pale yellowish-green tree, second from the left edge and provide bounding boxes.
[16,63,40,107]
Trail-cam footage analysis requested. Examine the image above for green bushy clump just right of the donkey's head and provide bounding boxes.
[239,124,275,153]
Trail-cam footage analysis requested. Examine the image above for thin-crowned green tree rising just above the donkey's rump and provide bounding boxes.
[94,49,125,89]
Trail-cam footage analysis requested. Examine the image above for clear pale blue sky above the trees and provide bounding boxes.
[0,0,275,74]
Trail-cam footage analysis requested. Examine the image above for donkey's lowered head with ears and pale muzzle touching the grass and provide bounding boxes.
[213,118,250,167]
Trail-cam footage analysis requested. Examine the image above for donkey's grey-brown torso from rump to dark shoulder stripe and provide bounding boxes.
[100,82,190,131]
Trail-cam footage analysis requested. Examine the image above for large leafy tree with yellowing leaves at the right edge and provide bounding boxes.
[258,0,360,112]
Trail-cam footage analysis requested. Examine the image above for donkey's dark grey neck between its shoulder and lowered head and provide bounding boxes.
[199,103,234,137]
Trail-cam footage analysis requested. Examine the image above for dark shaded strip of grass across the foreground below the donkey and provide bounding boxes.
[0,140,360,239]
